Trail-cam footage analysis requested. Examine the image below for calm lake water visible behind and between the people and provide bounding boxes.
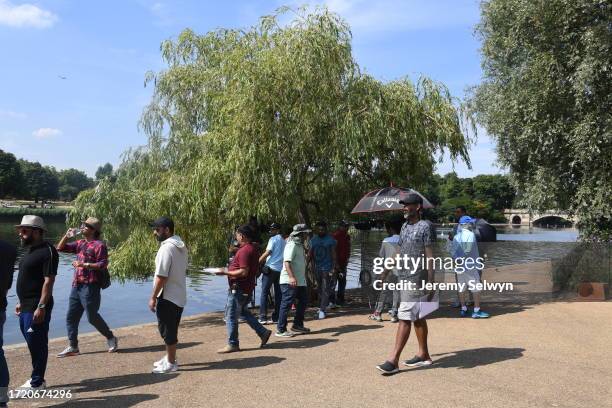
[0,219,577,344]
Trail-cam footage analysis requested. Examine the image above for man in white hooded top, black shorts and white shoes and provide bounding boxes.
[149,217,188,374]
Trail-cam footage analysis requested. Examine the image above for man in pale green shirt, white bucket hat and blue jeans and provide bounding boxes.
[274,224,310,337]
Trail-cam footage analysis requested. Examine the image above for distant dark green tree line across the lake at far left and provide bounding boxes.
[0,150,113,202]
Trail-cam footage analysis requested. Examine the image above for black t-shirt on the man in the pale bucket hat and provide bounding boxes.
[17,242,59,312]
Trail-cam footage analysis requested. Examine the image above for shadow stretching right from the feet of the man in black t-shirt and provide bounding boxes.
[53,373,178,395]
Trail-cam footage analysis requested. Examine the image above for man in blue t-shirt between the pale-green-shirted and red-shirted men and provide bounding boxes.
[308,221,336,319]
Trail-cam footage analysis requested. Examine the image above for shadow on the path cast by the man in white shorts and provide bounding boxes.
[427,347,525,369]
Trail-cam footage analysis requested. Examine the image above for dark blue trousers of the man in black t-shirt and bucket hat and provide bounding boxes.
[19,309,51,387]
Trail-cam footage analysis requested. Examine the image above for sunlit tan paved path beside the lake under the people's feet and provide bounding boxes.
[6,262,612,408]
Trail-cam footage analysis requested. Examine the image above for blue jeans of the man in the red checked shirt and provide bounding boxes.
[66,283,115,348]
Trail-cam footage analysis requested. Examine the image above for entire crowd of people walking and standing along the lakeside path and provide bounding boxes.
[0,194,488,406]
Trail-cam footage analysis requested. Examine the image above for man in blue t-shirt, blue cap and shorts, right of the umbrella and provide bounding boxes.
[451,215,489,319]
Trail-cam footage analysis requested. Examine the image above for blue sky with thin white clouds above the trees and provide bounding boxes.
[0,0,503,177]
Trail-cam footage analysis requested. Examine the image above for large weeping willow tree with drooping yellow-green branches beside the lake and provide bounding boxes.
[72,8,472,278]
